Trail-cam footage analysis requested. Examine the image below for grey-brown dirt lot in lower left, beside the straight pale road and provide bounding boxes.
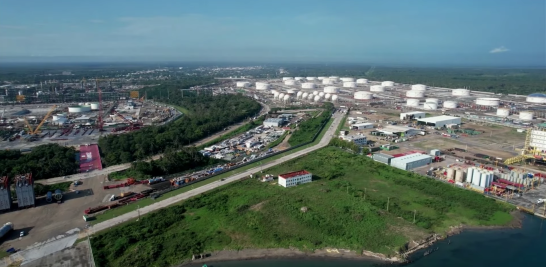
[0,176,153,250]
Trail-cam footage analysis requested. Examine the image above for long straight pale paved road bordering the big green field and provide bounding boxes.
[85,113,343,238]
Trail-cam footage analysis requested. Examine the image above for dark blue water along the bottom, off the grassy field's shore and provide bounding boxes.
[185,215,546,267]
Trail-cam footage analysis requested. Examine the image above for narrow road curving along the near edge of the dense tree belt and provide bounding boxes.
[38,103,270,185]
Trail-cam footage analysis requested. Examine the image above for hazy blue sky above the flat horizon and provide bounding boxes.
[0,0,546,66]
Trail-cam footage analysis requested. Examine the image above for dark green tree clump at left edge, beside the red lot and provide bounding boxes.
[0,144,79,180]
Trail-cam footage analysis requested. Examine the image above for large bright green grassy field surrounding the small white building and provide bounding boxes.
[91,148,511,267]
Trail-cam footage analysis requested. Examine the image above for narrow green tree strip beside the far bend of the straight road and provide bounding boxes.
[288,103,334,146]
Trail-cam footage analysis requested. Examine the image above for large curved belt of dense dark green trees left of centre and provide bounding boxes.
[99,92,261,165]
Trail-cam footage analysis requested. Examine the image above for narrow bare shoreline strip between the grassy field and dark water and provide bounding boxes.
[177,210,524,266]
